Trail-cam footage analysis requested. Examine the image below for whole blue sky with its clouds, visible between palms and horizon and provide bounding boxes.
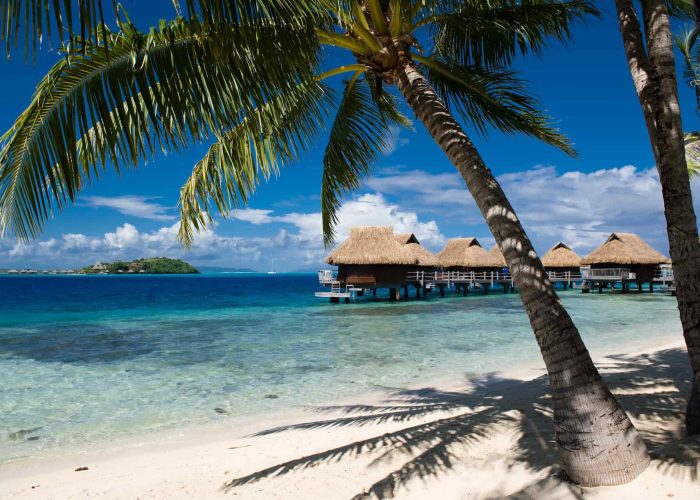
[0,0,700,271]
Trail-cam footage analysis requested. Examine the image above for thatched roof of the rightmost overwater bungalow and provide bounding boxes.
[581,233,669,265]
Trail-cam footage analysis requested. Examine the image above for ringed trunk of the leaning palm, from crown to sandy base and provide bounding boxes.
[396,61,649,486]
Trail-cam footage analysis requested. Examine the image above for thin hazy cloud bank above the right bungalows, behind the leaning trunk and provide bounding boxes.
[366,165,700,253]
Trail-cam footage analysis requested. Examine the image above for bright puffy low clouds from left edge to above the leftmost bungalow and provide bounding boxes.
[0,194,444,270]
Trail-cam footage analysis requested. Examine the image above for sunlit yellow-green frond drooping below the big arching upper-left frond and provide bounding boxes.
[178,80,332,245]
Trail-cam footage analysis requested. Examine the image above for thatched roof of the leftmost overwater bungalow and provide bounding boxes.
[326,226,419,266]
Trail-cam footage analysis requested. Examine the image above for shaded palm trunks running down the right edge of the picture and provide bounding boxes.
[615,0,700,435]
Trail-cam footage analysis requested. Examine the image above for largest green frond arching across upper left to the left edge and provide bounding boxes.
[0,18,318,239]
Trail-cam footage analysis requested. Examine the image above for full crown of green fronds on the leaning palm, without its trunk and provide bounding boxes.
[0,0,594,243]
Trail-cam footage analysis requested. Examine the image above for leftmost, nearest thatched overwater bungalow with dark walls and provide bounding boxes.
[326,226,422,300]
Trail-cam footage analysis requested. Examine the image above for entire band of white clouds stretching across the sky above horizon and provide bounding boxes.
[0,166,700,270]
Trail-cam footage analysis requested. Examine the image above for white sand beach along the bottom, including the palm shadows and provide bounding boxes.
[0,337,700,498]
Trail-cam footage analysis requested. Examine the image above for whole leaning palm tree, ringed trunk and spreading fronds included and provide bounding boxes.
[0,0,649,485]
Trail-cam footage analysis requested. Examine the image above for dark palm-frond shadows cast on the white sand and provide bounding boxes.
[221,349,700,498]
